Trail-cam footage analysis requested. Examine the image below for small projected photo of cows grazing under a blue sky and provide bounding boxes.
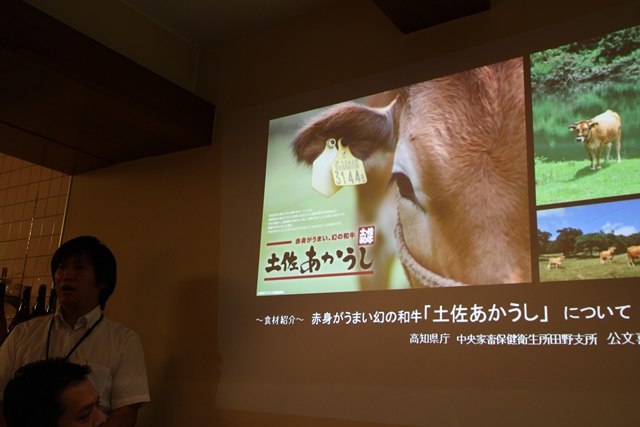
[537,199,640,282]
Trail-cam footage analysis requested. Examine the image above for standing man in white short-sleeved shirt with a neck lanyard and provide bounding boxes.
[0,236,150,427]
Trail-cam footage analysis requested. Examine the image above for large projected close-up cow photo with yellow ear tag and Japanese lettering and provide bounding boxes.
[257,58,531,295]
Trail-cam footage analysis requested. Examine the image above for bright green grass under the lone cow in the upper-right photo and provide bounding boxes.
[535,158,640,205]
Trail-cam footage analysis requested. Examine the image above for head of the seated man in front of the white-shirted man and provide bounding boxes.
[3,359,106,427]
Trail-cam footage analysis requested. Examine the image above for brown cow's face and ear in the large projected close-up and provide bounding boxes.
[292,59,531,287]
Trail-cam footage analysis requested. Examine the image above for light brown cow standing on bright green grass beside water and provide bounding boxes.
[569,110,622,171]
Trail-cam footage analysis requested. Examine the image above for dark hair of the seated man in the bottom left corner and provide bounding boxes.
[3,358,91,427]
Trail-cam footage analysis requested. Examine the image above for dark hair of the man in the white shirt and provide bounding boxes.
[51,236,117,310]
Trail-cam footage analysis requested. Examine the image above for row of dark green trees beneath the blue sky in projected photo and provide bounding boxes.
[538,227,640,257]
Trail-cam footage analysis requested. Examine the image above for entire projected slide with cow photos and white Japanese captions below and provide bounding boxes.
[216,15,640,427]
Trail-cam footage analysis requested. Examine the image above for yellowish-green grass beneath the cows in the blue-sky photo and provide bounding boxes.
[538,254,640,282]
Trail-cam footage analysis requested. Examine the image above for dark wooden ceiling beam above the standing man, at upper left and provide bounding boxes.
[0,0,215,174]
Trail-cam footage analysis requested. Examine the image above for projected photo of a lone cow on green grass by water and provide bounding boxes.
[531,27,640,206]
